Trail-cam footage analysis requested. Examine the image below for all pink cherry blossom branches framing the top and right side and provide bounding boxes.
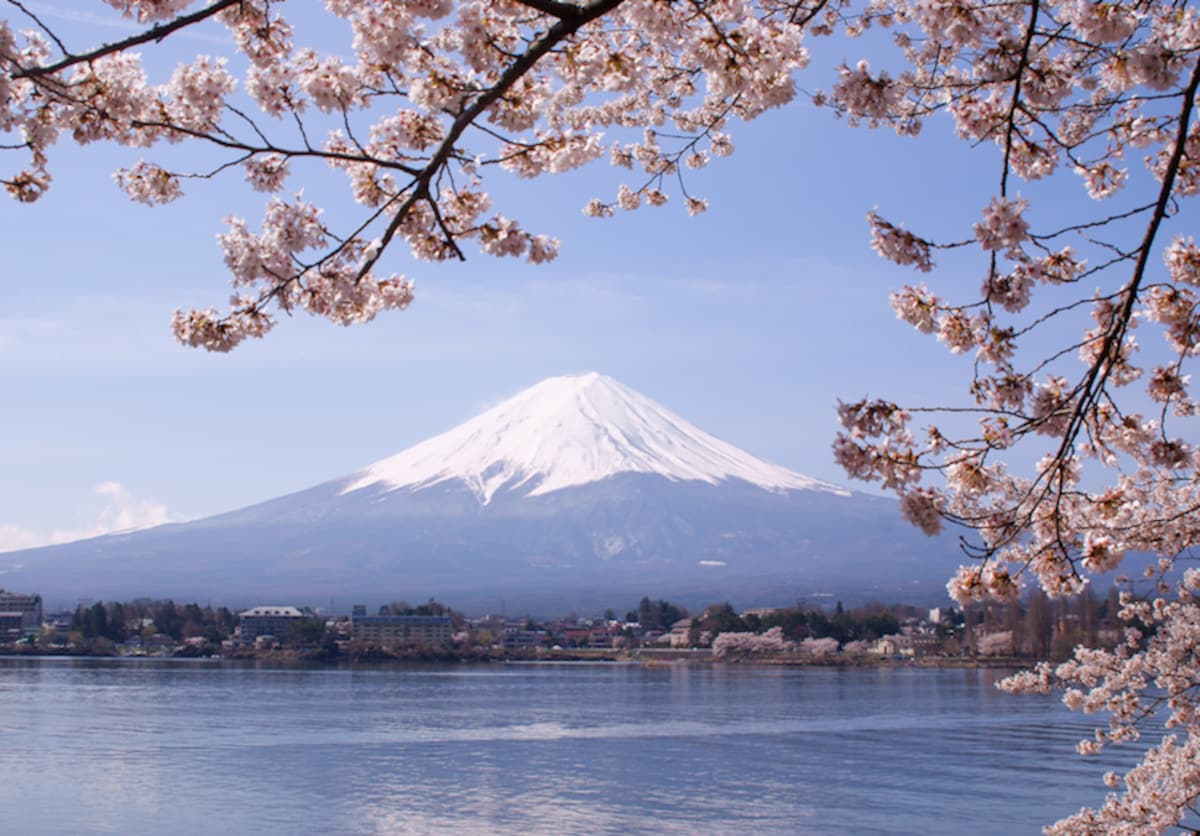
[7,0,1200,832]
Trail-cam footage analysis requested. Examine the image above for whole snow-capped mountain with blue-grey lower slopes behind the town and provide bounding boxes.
[0,373,960,613]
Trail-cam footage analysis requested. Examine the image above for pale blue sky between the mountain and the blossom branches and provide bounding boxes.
[0,3,1012,548]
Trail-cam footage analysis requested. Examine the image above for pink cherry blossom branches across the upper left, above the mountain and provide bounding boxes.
[0,0,808,350]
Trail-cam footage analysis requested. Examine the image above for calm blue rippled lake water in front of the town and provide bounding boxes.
[0,658,1118,835]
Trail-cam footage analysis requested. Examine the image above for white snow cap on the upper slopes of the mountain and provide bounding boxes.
[341,372,848,505]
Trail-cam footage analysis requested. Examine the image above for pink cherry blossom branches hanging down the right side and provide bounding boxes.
[821,0,1200,834]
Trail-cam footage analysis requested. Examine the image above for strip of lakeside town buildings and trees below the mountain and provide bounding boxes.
[0,580,1120,664]
